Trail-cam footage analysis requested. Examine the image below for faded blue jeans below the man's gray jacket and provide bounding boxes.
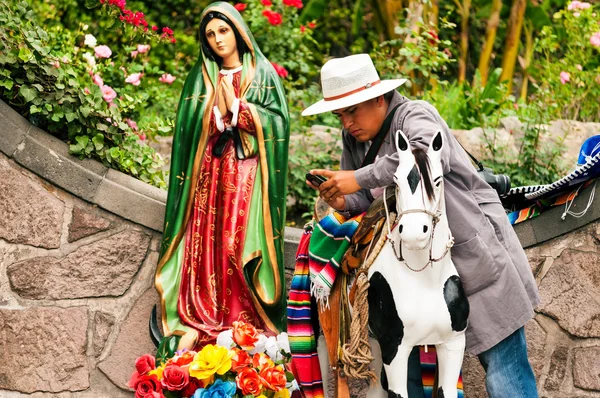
[478,328,538,398]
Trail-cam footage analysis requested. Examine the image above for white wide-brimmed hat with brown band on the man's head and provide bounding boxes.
[302,54,406,116]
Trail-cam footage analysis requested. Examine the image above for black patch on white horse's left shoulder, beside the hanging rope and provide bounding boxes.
[368,272,404,365]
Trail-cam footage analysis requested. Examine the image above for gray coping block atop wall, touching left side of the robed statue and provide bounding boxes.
[93,170,166,232]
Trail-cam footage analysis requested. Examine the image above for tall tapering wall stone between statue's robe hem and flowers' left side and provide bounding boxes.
[98,287,160,389]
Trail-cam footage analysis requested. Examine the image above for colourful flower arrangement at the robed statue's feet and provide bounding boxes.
[129,322,298,398]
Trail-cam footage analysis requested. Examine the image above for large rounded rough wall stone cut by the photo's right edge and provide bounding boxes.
[538,249,600,337]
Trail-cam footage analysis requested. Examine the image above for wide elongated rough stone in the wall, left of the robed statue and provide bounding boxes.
[7,230,150,300]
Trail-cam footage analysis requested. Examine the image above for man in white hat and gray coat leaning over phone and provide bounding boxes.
[302,54,539,398]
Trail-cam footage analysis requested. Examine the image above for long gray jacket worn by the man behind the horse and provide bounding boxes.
[341,92,539,355]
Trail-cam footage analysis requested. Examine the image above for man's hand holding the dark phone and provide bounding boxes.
[306,169,361,211]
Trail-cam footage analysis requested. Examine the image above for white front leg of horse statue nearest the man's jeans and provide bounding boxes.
[435,333,465,398]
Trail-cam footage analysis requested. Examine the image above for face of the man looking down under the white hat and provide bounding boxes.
[333,96,387,142]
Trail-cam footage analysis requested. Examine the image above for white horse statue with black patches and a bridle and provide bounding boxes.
[368,131,469,398]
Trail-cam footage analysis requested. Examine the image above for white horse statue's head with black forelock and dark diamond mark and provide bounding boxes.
[394,130,444,250]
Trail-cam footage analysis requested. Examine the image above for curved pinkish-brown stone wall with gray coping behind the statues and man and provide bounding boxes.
[0,98,600,398]
